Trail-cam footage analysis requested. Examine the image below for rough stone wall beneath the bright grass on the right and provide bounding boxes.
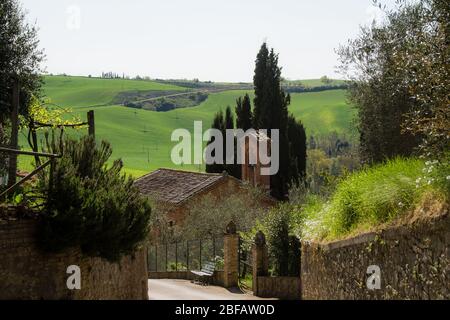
[302,214,450,299]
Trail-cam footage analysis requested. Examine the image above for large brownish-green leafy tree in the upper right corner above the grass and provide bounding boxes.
[338,0,450,162]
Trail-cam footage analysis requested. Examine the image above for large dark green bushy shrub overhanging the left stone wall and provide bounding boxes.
[40,137,151,261]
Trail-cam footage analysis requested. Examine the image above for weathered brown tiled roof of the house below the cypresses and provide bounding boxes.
[134,169,224,204]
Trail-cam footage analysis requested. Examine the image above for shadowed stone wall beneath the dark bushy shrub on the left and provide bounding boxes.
[0,220,148,299]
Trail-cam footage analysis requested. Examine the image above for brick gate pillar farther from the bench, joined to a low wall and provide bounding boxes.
[252,231,269,296]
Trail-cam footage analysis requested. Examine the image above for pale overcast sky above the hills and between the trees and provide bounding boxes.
[22,0,384,82]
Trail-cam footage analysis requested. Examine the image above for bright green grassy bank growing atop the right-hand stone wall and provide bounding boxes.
[300,158,450,239]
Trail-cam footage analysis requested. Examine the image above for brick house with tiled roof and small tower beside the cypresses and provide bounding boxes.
[135,132,276,238]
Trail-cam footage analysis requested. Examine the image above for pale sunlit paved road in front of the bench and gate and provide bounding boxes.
[148,279,274,300]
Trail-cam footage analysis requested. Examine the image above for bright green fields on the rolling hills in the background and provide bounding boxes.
[21,77,353,176]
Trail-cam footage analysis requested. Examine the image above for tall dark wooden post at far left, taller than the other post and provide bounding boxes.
[8,78,20,187]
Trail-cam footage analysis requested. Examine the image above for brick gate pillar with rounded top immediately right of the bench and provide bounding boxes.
[223,221,239,288]
